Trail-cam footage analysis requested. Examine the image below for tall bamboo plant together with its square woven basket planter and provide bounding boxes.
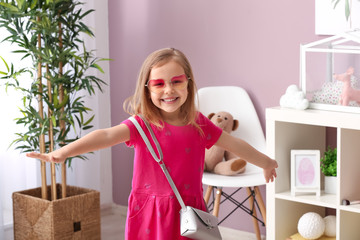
[0,0,107,239]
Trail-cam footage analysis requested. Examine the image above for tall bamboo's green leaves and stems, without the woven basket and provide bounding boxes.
[0,0,108,200]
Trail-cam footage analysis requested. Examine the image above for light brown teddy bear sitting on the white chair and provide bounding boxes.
[204,112,246,176]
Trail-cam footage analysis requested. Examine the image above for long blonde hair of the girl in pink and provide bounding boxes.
[123,48,200,129]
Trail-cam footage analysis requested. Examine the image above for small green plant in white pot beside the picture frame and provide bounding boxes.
[320,146,337,194]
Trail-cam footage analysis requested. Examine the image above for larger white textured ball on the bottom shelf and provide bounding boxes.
[298,212,325,239]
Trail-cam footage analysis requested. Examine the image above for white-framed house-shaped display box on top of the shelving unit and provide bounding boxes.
[300,29,360,113]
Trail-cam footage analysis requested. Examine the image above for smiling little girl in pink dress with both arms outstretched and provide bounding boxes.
[27,48,277,240]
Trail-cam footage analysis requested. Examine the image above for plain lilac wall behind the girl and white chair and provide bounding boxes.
[109,0,320,233]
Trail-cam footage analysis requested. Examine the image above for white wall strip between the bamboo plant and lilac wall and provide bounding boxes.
[68,0,113,206]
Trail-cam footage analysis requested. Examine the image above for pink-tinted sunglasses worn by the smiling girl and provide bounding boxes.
[145,74,190,93]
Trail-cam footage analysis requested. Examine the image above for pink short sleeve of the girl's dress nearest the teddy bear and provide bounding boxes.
[198,112,223,149]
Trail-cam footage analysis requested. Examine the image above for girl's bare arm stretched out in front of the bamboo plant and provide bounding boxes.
[26,124,130,162]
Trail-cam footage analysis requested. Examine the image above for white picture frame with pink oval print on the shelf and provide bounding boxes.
[291,150,321,197]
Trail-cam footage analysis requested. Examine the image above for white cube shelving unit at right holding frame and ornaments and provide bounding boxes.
[266,107,360,240]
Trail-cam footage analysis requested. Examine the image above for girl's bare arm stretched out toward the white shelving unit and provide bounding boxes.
[215,131,278,182]
